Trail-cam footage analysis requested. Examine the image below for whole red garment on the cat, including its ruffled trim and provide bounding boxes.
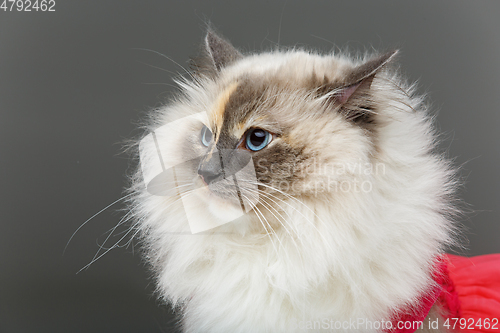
[386,254,500,333]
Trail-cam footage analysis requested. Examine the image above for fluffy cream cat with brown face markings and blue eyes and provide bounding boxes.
[129,29,456,333]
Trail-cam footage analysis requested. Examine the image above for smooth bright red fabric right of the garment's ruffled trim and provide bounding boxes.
[447,254,500,332]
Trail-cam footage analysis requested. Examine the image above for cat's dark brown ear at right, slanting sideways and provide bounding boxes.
[327,50,398,122]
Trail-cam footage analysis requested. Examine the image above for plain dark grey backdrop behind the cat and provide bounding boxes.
[0,0,500,332]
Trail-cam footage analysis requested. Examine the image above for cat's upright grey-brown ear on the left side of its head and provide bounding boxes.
[192,28,243,77]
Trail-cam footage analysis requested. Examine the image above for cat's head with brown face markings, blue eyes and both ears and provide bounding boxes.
[136,31,396,232]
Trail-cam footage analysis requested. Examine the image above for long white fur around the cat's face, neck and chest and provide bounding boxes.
[129,50,453,333]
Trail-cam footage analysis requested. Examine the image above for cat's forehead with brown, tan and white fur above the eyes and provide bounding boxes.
[203,52,352,137]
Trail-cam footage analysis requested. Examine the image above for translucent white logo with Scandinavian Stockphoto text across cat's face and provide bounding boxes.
[139,112,386,234]
